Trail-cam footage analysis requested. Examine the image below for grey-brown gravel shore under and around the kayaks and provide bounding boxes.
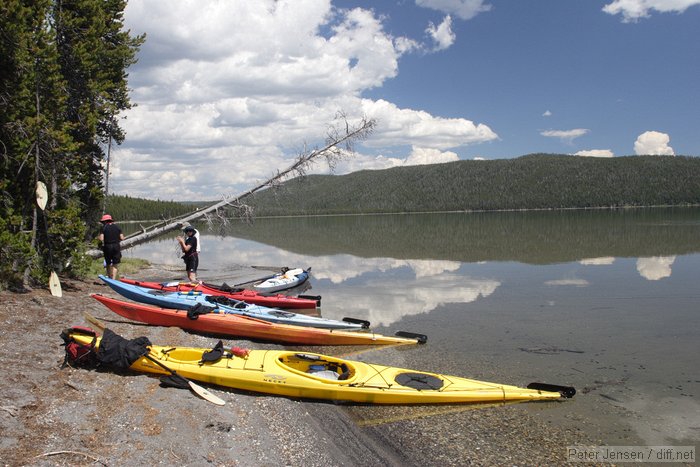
[0,267,591,466]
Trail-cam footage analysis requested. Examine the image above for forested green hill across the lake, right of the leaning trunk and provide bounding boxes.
[245,154,700,216]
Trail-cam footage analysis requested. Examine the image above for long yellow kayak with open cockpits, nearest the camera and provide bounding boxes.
[71,332,575,404]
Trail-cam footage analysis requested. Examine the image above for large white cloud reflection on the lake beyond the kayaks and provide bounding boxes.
[180,237,500,326]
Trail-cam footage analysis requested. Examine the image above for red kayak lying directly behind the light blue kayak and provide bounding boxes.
[119,278,321,309]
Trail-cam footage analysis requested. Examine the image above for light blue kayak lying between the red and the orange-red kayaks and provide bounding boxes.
[99,275,369,330]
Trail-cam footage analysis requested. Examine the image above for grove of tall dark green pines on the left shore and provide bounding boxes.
[0,0,144,288]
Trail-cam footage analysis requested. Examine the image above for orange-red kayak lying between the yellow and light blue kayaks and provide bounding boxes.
[91,294,427,345]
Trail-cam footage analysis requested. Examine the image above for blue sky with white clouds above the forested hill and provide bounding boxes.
[109,0,700,201]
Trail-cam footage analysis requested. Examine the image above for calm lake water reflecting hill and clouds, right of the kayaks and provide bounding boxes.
[125,208,700,445]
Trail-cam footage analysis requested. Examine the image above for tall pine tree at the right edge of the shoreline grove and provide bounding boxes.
[53,0,144,227]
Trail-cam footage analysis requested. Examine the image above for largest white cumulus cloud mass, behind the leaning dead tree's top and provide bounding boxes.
[110,0,497,200]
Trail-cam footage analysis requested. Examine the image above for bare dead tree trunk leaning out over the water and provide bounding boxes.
[87,114,376,258]
